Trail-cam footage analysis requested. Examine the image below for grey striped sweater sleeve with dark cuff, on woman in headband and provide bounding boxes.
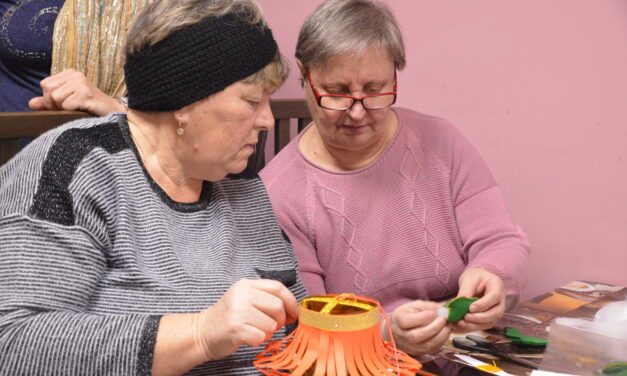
[0,215,159,375]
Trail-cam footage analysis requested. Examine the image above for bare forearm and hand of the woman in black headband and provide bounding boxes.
[152,279,298,376]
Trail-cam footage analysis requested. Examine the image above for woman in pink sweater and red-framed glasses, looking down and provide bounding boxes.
[261,0,529,355]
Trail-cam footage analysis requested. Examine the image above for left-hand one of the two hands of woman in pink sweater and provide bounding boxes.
[390,300,451,356]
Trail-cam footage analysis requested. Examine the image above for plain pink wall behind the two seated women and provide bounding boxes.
[259,0,627,297]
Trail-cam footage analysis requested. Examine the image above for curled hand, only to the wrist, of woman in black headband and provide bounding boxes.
[197,279,298,360]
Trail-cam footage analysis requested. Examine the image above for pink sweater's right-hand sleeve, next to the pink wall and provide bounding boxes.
[451,123,529,301]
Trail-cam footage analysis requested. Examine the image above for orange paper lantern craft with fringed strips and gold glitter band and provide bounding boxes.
[254,294,426,376]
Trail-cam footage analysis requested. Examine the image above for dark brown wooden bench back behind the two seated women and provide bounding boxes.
[0,99,311,171]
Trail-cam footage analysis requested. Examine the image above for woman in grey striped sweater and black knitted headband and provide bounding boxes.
[0,0,305,375]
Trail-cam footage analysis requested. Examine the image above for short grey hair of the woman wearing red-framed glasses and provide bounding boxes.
[296,0,405,70]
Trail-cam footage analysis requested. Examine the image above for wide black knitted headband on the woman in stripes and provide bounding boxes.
[124,16,277,111]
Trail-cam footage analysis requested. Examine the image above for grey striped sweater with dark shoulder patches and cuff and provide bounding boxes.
[0,114,305,375]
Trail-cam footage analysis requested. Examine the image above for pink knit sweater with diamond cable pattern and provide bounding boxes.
[260,108,529,312]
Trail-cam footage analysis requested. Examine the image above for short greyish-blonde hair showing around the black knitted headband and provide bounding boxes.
[125,0,289,89]
